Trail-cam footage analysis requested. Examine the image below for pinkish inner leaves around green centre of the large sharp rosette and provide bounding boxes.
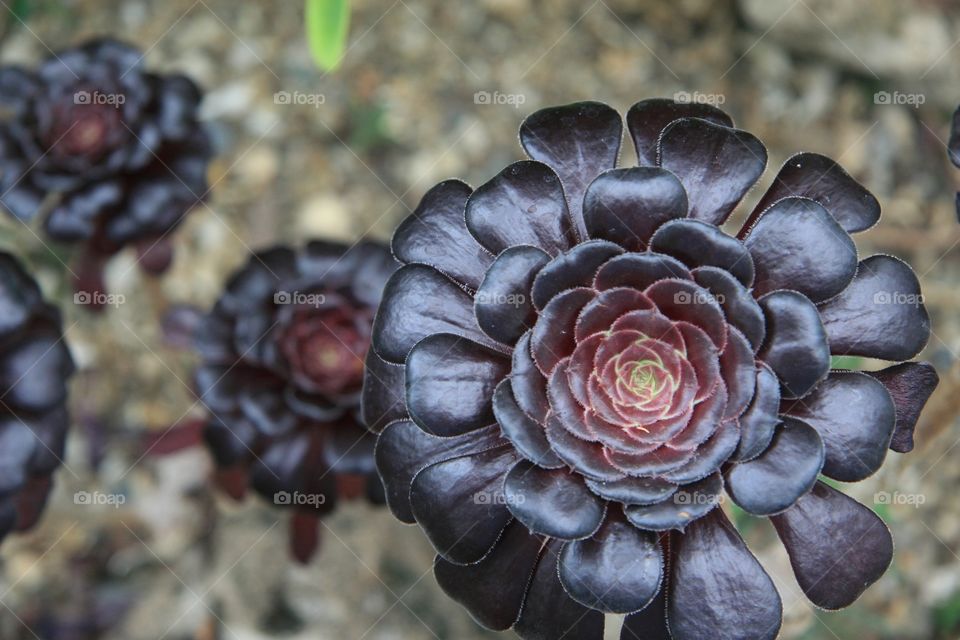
[532,264,744,477]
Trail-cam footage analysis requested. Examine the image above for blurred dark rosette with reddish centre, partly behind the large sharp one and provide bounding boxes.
[195,242,397,562]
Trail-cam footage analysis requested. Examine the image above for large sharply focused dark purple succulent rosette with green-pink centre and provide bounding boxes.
[364,100,937,639]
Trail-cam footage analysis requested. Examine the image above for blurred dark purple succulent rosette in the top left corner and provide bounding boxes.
[0,39,212,308]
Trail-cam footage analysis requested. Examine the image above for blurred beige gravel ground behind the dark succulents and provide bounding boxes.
[0,0,960,640]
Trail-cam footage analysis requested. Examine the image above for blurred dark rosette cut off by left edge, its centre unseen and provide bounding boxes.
[0,251,74,539]
